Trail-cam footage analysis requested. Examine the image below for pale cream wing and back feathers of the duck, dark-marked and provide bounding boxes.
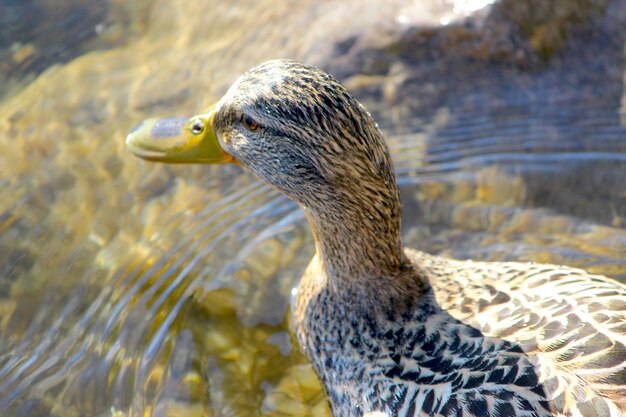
[407,251,626,416]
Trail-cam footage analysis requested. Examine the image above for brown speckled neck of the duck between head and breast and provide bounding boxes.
[303,175,406,290]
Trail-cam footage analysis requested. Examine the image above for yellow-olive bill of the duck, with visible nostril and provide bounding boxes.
[126,105,236,164]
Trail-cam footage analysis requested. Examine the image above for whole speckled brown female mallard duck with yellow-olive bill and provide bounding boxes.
[127,60,626,417]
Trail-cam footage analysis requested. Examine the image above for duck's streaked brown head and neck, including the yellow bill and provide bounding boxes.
[126,60,403,276]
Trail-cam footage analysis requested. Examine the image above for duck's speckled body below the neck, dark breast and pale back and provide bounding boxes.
[295,249,626,417]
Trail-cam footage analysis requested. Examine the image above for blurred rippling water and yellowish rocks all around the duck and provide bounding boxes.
[0,0,626,417]
